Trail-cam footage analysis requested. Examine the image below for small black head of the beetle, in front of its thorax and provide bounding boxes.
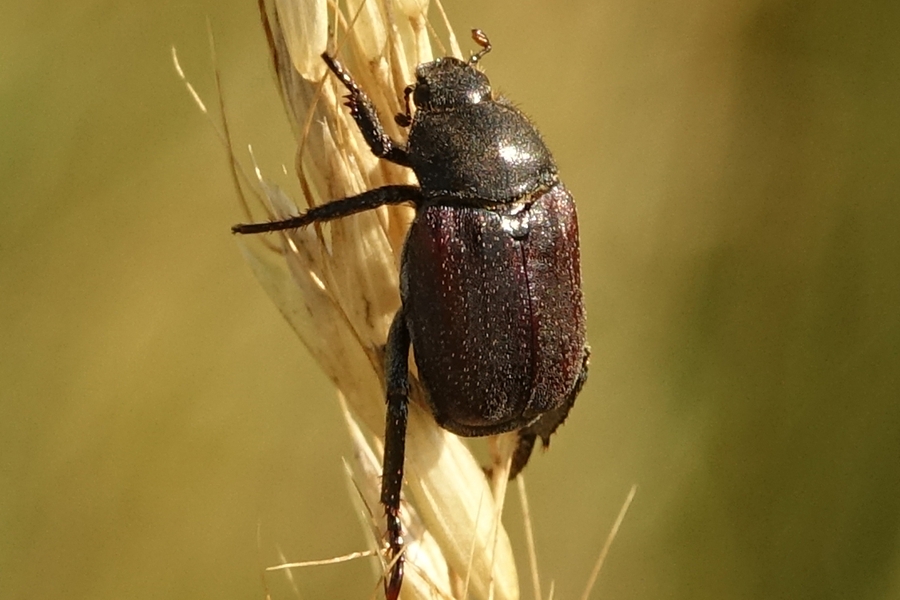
[413,56,491,110]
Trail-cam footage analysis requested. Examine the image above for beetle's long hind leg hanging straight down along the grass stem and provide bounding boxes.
[381,308,410,600]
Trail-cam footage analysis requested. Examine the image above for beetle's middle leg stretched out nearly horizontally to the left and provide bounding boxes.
[231,185,424,233]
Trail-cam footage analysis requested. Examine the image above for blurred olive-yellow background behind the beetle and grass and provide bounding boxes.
[0,0,900,599]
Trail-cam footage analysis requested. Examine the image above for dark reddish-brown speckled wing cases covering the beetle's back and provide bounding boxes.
[402,184,585,435]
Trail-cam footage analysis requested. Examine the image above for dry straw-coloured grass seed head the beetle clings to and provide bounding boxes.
[239,0,519,600]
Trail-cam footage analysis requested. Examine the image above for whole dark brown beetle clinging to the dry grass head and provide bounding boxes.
[232,29,590,600]
